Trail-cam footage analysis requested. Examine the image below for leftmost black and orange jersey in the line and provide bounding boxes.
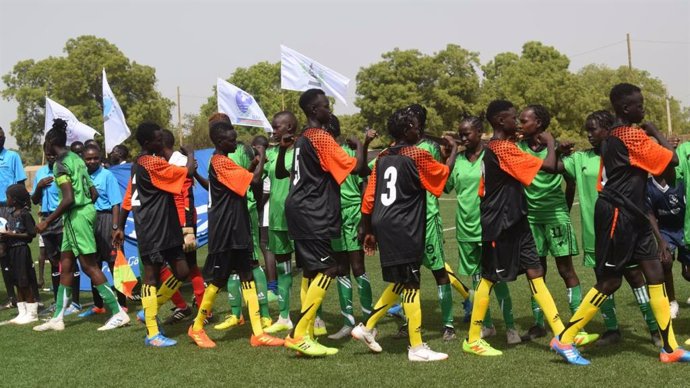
[122,155,187,256]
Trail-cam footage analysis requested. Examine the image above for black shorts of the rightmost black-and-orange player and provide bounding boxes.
[594,198,659,275]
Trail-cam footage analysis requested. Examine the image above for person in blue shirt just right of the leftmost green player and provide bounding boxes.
[79,144,127,318]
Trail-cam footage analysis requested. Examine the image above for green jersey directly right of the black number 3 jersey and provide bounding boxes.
[445,151,484,242]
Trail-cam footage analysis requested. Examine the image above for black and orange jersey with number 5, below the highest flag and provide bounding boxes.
[285,128,357,240]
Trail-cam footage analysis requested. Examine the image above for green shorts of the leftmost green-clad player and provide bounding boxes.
[60,204,96,256]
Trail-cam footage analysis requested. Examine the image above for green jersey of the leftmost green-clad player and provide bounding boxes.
[53,151,93,208]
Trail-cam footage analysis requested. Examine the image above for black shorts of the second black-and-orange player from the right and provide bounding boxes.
[481,218,542,283]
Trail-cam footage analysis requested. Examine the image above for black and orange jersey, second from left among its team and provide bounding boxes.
[208,154,254,255]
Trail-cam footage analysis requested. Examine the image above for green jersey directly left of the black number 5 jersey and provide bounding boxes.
[264,146,294,231]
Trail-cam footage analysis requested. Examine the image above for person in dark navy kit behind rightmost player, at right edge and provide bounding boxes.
[647,170,690,319]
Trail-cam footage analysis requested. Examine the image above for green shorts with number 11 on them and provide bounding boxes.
[529,221,580,257]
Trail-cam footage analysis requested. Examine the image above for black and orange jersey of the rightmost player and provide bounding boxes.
[601,126,673,210]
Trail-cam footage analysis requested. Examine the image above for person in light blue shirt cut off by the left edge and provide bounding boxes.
[0,128,28,310]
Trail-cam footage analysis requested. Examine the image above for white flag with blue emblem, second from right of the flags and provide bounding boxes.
[216,78,273,132]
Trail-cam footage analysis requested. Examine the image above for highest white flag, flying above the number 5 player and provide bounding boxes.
[280,45,350,105]
